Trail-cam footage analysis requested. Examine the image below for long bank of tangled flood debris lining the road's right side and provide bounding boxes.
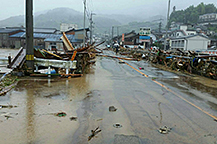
[106,47,217,80]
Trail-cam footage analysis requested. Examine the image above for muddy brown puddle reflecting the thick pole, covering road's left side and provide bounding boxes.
[0,75,96,144]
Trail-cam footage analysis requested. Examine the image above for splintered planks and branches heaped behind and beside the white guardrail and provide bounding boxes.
[34,33,104,77]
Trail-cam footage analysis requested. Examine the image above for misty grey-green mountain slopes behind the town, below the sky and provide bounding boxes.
[0,8,165,34]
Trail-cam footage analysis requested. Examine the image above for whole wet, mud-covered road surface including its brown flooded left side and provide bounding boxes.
[0,51,217,144]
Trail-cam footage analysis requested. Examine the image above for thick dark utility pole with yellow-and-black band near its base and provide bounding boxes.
[26,0,34,71]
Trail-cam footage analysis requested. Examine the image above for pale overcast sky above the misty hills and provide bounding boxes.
[0,0,217,20]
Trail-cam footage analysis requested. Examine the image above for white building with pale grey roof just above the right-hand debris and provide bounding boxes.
[170,34,210,51]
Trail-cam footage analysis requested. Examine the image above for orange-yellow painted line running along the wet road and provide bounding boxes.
[119,59,217,121]
